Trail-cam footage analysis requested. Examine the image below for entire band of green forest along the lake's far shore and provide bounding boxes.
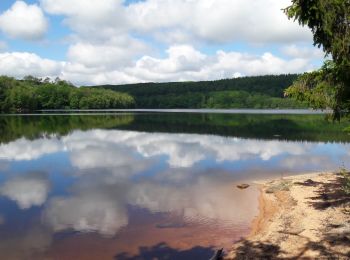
[0,74,306,112]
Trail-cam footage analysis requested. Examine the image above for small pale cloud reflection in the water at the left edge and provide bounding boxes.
[0,173,50,209]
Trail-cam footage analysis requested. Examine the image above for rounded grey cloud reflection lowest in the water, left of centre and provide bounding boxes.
[44,187,128,235]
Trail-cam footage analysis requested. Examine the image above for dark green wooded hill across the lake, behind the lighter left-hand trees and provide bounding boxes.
[93,74,306,108]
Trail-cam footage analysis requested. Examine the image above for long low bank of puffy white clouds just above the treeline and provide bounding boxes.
[0,45,316,85]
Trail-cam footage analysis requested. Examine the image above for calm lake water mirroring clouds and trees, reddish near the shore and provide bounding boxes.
[0,111,350,259]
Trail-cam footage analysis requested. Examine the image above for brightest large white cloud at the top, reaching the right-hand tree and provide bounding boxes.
[127,0,311,43]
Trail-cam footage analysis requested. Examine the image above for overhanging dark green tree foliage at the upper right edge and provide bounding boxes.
[284,0,350,114]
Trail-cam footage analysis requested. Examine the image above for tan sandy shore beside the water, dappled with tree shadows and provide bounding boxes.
[226,173,350,259]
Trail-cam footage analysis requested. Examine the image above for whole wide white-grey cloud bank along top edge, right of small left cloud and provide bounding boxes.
[40,0,311,43]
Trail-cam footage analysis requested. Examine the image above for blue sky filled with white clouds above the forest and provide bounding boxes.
[0,0,324,85]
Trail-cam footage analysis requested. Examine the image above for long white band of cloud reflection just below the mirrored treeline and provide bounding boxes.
[0,130,350,171]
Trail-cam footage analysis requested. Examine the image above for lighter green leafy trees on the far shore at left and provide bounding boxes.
[0,76,135,112]
